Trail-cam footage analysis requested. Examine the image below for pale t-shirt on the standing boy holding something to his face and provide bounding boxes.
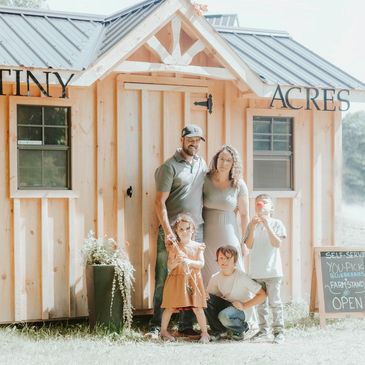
[244,218,286,279]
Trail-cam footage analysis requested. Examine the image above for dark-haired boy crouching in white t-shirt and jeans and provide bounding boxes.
[205,246,266,340]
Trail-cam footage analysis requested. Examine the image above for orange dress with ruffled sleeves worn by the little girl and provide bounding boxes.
[161,241,207,310]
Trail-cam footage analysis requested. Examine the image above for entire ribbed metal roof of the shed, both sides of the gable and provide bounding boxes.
[0,0,365,89]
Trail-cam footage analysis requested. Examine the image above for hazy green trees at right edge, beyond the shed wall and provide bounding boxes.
[342,111,365,202]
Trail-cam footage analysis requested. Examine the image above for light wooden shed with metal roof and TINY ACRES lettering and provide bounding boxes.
[0,0,365,323]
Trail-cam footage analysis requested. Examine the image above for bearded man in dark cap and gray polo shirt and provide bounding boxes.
[150,124,207,337]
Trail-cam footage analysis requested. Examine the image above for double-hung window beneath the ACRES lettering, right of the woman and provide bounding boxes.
[253,117,293,190]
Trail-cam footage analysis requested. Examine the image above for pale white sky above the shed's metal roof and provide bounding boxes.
[47,0,365,112]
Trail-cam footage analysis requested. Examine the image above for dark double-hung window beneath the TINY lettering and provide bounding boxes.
[17,105,71,189]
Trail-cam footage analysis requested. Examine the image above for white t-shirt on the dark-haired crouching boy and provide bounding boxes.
[207,269,261,302]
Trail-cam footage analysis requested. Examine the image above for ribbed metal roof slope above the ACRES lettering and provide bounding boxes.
[217,28,365,89]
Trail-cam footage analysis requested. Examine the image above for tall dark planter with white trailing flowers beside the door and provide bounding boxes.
[82,231,135,329]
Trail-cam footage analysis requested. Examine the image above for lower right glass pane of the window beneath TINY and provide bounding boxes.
[43,151,68,188]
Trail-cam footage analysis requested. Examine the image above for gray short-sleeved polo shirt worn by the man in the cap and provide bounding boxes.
[155,149,207,225]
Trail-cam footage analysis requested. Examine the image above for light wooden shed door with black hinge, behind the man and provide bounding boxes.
[118,78,208,310]
